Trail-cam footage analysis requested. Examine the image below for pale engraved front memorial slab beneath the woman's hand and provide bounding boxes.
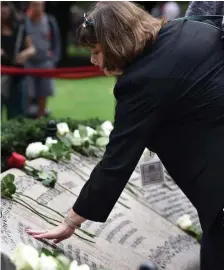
[1,155,199,270]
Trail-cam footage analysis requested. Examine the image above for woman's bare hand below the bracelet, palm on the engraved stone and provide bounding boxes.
[26,223,75,244]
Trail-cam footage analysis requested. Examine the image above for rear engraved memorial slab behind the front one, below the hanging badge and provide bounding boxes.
[56,152,201,229]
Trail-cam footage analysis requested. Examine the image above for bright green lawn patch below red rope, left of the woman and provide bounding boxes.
[48,77,115,120]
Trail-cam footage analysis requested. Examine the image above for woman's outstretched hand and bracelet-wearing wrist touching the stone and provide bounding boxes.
[26,209,86,244]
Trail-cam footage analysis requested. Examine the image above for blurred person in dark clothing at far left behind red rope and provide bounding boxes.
[1,2,35,119]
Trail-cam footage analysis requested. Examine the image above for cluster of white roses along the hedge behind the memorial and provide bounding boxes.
[23,121,113,165]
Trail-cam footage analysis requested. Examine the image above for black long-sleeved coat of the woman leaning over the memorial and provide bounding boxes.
[73,21,224,231]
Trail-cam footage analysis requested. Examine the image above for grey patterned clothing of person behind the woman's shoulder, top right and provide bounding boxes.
[186,1,224,29]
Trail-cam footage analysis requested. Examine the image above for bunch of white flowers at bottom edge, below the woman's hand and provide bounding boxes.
[11,243,90,270]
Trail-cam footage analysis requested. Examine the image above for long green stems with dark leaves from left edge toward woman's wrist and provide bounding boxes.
[1,173,95,243]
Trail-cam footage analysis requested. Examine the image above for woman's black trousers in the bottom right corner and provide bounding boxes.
[201,210,224,270]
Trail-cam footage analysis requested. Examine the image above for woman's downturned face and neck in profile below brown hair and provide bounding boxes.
[90,44,121,76]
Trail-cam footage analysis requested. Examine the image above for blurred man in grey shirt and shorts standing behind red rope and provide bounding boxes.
[25,1,61,118]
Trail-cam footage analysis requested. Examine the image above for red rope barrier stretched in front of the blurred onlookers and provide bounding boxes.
[1,66,104,79]
